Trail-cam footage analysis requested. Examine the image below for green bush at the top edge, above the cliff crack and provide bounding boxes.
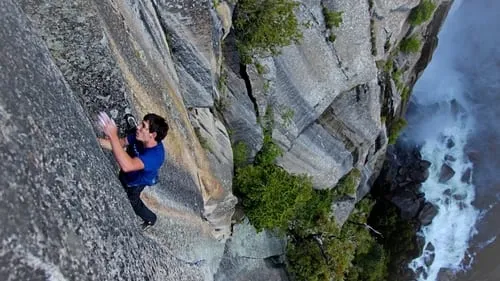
[234,0,302,64]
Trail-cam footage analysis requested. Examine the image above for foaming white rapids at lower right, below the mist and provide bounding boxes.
[410,95,480,281]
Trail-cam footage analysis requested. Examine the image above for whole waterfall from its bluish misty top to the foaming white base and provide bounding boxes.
[406,1,480,276]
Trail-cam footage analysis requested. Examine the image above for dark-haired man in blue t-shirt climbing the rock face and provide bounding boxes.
[99,110,169,229]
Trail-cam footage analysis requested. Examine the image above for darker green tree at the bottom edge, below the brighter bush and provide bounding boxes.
[287,197,387,281]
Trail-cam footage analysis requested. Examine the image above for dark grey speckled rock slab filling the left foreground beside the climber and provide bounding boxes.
[0,0,202,280]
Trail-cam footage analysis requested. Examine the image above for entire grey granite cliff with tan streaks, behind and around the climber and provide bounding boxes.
[0,0,450,280]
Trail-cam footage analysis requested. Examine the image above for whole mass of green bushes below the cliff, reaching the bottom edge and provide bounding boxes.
[233,108,386,281]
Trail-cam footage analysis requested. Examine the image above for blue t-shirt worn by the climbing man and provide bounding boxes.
[122,134,165,187]
